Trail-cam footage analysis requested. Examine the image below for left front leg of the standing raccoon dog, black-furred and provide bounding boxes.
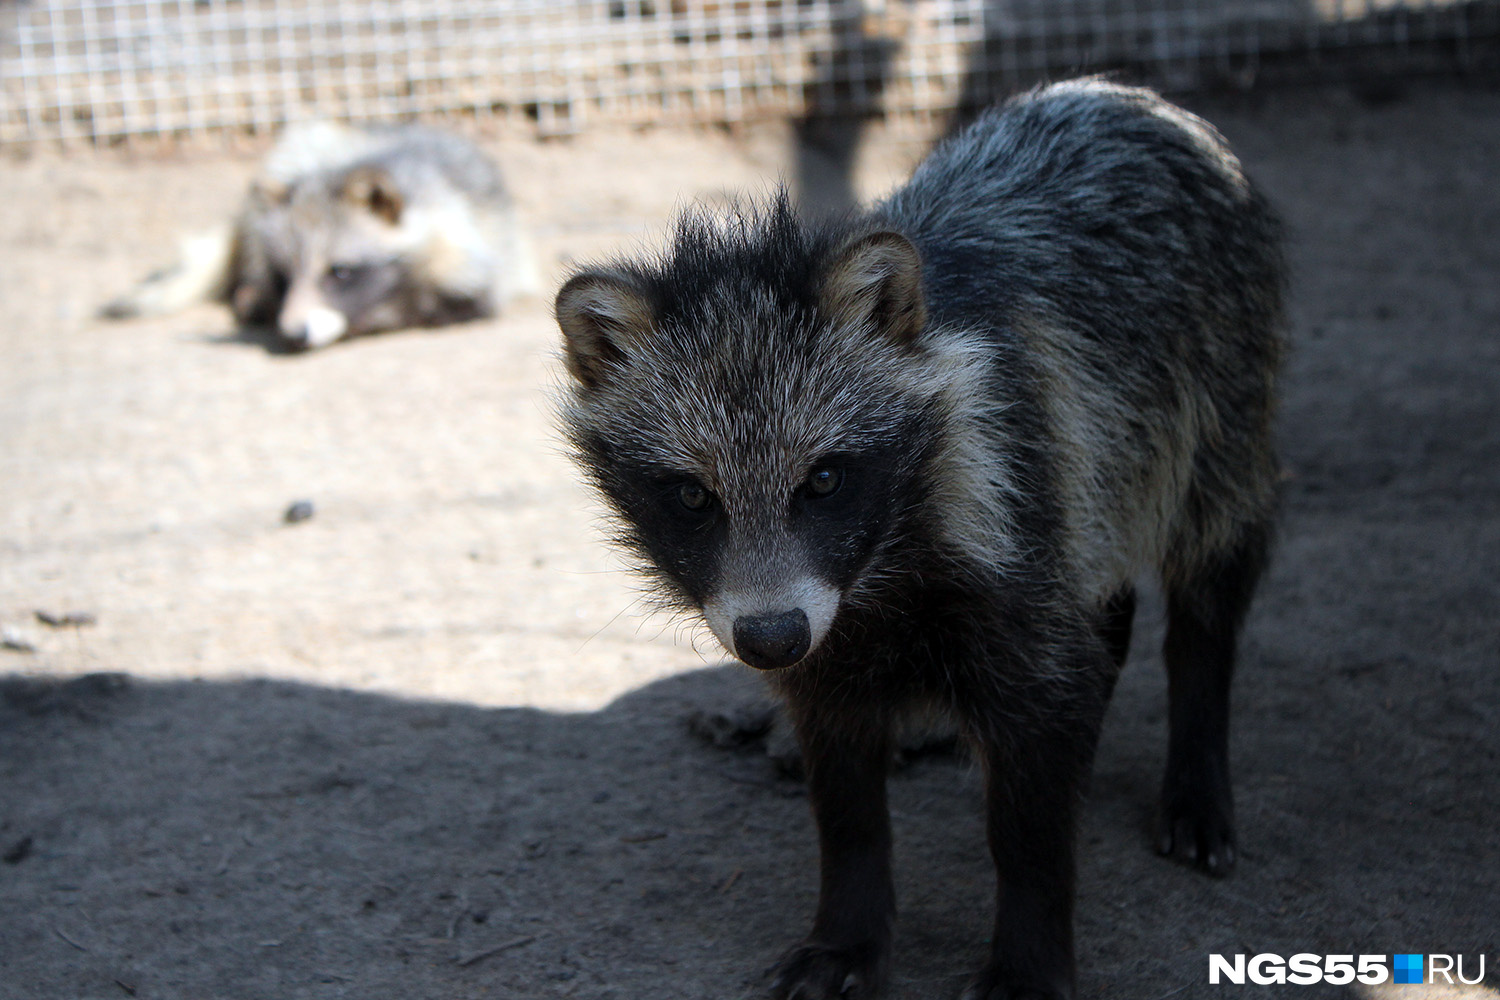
[771,709,896,1000]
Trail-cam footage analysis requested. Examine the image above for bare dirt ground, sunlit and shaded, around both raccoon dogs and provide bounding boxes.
[0,82,1500,1000]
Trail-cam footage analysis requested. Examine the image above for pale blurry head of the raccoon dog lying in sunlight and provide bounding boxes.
[252,166,438,348]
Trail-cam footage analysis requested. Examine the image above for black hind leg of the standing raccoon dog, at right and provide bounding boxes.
[1158,515,1271,876]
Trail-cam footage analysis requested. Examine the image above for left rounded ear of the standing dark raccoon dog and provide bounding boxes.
[557,271,656,388]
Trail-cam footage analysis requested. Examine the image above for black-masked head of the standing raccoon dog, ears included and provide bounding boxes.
[557,199,990,669]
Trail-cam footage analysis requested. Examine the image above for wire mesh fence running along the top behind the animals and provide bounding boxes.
[0,0,1500,144]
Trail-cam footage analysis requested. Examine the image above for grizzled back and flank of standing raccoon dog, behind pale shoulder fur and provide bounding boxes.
[876,79,1283,598]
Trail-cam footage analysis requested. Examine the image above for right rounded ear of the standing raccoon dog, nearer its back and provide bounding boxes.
[819,232,927,346]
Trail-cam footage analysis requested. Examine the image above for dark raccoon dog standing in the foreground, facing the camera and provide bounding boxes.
[557,79,1283,1000]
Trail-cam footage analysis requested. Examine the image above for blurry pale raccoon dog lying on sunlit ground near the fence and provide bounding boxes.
[101,123,536,348]
